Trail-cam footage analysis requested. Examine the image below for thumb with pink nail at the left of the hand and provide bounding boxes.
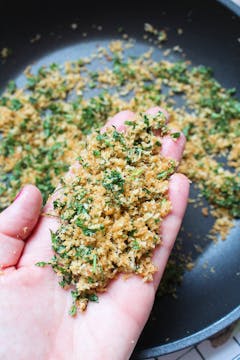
[0,185,42,268]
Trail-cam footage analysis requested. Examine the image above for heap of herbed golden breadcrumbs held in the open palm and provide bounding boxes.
[40,112,176,315]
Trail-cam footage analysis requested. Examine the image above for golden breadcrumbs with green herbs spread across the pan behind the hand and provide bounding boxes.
[0,33,240,298]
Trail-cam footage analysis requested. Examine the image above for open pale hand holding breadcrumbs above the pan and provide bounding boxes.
[0,108,189,360]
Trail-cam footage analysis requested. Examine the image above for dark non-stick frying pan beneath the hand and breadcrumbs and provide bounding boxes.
[0,0,240,359]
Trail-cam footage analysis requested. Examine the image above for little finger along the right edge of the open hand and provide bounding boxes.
[153,174,190,290]
